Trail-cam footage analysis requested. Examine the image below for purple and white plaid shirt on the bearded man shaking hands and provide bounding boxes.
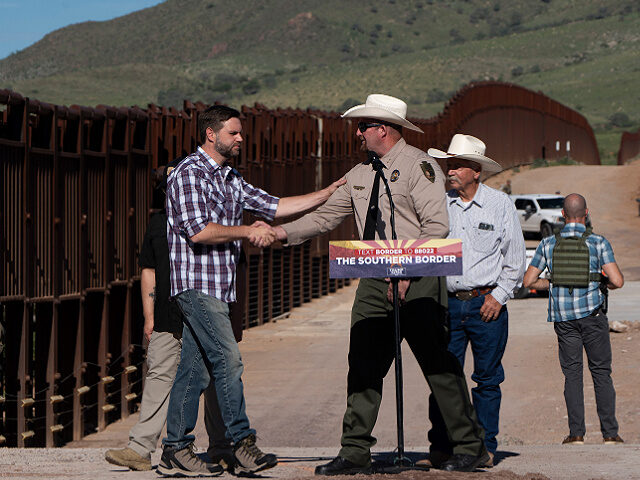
[166,147,278,303]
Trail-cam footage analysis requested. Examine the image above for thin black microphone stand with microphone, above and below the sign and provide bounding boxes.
[369,155,422,473]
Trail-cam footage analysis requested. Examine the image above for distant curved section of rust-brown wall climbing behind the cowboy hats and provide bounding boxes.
[407,82,600,168]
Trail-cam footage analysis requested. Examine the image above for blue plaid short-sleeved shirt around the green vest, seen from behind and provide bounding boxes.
[531,223,616,322]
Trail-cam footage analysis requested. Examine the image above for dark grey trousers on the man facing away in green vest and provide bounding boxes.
[553,312,618,437]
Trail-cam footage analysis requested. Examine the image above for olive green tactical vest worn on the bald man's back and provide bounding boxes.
[551,227,601,293]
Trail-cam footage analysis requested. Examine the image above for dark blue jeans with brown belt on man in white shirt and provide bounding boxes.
[449,295,509,453]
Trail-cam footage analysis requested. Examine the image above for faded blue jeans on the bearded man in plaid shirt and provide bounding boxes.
[163,290,255,449]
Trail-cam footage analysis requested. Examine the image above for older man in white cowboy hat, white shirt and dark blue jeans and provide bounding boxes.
[427,134,525,467]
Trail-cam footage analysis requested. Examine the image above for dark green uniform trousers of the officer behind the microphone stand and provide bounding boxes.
[339,281,484,465]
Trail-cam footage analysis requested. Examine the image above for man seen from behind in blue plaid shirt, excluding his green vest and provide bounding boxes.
[523,193,624,445]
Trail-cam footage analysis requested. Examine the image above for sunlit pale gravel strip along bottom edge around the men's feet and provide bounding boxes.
[0,445,640,480]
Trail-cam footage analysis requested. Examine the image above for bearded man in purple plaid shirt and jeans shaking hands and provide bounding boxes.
[158,105,345,476]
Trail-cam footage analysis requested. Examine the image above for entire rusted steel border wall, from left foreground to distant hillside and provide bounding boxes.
[0,83,599,446]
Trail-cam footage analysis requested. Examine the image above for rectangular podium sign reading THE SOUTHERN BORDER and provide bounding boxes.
[329,238,462,278]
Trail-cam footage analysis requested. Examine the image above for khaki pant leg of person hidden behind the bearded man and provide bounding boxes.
[128,331,182,457]
